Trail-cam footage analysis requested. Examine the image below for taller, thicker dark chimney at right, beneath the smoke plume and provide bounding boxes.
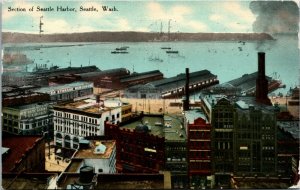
[256,52,272,105]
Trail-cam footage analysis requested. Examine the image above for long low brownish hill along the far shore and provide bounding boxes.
[2,32,273,43]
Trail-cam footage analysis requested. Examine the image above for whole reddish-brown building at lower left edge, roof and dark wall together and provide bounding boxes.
[1,136,45,174]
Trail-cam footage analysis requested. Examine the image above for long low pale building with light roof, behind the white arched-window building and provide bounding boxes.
[34,82,93,102]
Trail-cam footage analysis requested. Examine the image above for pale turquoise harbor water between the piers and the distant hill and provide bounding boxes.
[3,35,299,92]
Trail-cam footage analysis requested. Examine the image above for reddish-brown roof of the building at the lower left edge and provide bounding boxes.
[2,136,43,173]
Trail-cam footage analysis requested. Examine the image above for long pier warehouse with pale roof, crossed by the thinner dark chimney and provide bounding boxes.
[124,70,219,99]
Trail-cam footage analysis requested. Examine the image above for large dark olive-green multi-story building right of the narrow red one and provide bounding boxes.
[202,95,277,187]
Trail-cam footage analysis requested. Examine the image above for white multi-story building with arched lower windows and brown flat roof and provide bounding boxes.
[53,99,122,149]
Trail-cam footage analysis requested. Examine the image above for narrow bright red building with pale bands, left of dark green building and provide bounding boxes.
[187,118,211,187]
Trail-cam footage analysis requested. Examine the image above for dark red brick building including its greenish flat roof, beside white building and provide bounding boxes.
[105,116,165,173]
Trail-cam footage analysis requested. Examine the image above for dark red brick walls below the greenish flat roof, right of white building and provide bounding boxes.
[105,123,165,173]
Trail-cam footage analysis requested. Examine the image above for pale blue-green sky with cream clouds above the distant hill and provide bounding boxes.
[2,0,299,34]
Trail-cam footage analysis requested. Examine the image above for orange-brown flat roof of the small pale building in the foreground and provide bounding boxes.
[74,140,116,159]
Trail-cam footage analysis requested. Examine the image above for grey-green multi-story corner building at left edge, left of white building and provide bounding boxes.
[2,102,53,135]
